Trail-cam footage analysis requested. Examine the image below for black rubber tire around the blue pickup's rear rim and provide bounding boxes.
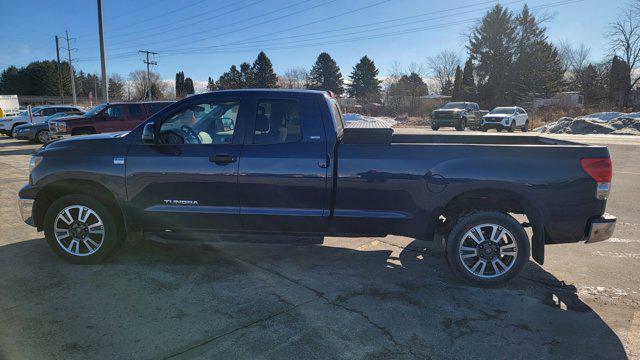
[446,210,530,287]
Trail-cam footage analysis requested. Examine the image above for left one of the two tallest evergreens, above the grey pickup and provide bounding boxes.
[468,4,517,107]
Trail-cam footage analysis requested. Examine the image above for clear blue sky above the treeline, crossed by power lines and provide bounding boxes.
[0,0,625,80]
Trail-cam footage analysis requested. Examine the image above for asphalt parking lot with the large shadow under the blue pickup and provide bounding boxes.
[0,129,640,359]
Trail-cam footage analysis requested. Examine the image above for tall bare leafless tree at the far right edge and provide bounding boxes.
[607,5,640,90]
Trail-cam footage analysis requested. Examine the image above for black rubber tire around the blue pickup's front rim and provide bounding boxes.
[43,194,124,265]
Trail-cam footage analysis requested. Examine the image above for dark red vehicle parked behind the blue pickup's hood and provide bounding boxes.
[49,101,172,138]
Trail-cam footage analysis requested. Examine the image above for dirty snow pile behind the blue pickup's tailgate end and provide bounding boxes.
[536,112,640,135]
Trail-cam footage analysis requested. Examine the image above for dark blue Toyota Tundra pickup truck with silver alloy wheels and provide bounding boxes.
[19,90,616,286]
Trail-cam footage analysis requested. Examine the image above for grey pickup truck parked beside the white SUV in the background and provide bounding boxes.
[431,102,482,131]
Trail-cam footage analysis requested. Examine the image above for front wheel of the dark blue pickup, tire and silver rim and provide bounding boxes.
[43,194,123,265]
